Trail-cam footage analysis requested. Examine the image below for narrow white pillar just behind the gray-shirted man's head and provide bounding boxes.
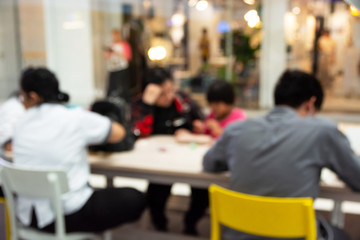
[259,0,288,108]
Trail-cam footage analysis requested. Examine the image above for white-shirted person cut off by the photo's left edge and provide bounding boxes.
[0,94,25,155]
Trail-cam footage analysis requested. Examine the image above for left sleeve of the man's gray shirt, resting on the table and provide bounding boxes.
[203,131,229,172]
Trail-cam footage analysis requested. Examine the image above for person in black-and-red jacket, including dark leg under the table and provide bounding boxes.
[134,67,204,234]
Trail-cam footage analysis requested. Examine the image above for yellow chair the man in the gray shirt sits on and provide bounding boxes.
[209,185,316,240]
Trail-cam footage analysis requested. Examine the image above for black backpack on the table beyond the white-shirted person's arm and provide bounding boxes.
[89,97,136,152]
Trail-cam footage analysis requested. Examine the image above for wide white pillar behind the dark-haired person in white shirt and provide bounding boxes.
[44,0,94,106]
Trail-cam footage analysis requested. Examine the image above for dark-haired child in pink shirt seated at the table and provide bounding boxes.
[193,80,246,138]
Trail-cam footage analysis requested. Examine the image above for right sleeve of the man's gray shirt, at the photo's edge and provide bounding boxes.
[323,128,360,191]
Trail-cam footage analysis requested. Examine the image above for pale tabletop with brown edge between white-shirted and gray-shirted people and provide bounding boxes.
[89,136,229,188]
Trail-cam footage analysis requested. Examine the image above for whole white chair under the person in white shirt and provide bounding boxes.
[0,164,111,240]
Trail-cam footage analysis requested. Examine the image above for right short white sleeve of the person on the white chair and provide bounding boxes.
[80,110,111,145]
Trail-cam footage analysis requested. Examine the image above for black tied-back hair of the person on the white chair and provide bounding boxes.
[20,68,70,103]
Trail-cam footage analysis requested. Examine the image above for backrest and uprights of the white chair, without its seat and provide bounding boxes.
[0,163,69,239]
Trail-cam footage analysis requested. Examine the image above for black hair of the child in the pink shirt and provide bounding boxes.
[206,79,235,104]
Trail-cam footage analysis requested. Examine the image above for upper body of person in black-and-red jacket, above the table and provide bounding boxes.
[133,67,204,137]
